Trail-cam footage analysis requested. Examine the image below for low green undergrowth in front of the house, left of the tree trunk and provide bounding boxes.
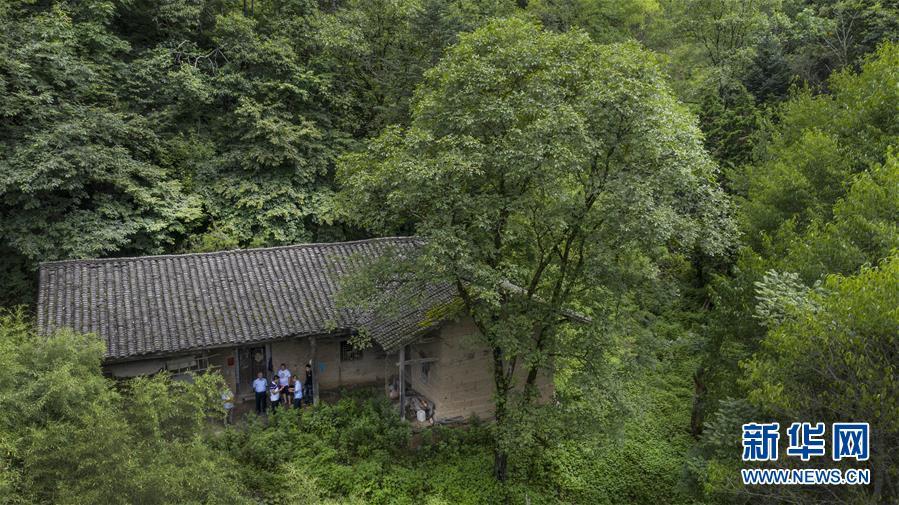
[214,395,506,504]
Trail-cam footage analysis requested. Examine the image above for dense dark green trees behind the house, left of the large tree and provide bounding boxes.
[0,0,528,305]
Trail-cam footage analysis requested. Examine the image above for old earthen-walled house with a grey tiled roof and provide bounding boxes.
[37,238,551,421]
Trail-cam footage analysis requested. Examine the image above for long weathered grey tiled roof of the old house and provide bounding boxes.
[37,238,454,359]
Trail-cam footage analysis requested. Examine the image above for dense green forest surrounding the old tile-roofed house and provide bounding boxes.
[0,0,899,505]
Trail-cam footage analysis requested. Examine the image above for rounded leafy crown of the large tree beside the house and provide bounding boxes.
[342,16,740,338]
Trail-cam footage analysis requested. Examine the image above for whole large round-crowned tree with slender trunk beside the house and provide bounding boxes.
[338,19,731,480]
